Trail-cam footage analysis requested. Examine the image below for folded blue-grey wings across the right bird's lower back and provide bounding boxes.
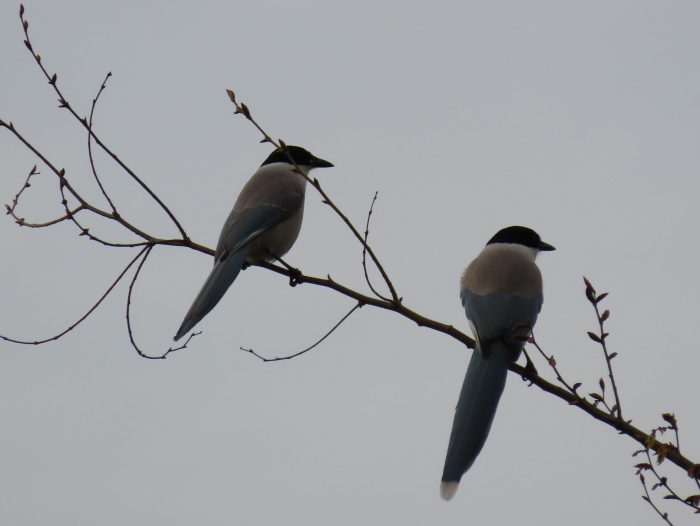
[461,289,543,350]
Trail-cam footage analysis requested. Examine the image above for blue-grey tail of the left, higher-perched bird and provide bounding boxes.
[174,245,250,341]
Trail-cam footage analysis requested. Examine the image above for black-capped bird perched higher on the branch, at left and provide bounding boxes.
[174,145,333,341]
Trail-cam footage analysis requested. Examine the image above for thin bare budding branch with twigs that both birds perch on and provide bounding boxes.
[0,10,700,524]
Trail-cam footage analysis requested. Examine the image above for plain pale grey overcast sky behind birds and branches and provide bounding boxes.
[0,0,700,526]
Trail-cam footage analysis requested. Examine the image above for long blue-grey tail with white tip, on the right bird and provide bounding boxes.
[440,342,513,500]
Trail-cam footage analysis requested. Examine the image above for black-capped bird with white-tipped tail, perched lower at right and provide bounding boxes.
[440,226,554,500]
